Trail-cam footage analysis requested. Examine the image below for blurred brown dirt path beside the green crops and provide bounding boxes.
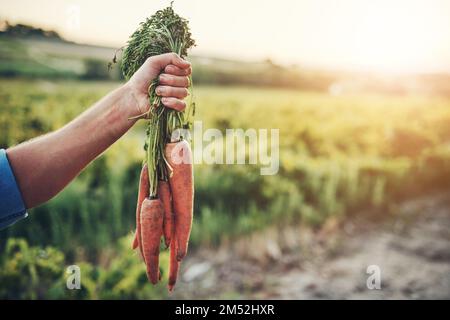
[174,193,450,299]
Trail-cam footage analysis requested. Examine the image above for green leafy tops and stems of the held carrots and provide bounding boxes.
[122,6,195,197]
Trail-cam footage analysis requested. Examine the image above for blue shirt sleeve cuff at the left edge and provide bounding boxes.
[0,149,28,230]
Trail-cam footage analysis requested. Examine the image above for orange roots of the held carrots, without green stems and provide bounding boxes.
[132,140,194,291]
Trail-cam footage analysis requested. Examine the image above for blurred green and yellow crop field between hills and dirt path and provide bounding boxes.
[0,79,450,299]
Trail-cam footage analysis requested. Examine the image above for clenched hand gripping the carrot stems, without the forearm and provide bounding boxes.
[126,53,192,117]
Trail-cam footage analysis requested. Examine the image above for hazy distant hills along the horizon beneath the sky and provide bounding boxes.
[0,21,450,96]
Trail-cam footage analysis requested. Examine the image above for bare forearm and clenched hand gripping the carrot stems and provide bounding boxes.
[6,53,191,208]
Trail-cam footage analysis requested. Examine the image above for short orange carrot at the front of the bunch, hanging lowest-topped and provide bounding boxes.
[141,198,164,284]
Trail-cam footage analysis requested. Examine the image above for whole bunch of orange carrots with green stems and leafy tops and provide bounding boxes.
[118,5,195,291]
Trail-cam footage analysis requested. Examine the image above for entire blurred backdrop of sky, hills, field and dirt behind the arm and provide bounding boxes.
[0,0,450,299]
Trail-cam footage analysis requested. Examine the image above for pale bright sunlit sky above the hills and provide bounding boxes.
[0,0,450,72]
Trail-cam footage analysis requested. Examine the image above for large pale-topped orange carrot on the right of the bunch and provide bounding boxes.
[165,140,194,261]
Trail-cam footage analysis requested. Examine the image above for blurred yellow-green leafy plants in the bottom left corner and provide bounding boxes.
[0,237,168,299]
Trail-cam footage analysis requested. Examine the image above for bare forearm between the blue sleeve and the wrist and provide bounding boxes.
[7,86,136,208]
